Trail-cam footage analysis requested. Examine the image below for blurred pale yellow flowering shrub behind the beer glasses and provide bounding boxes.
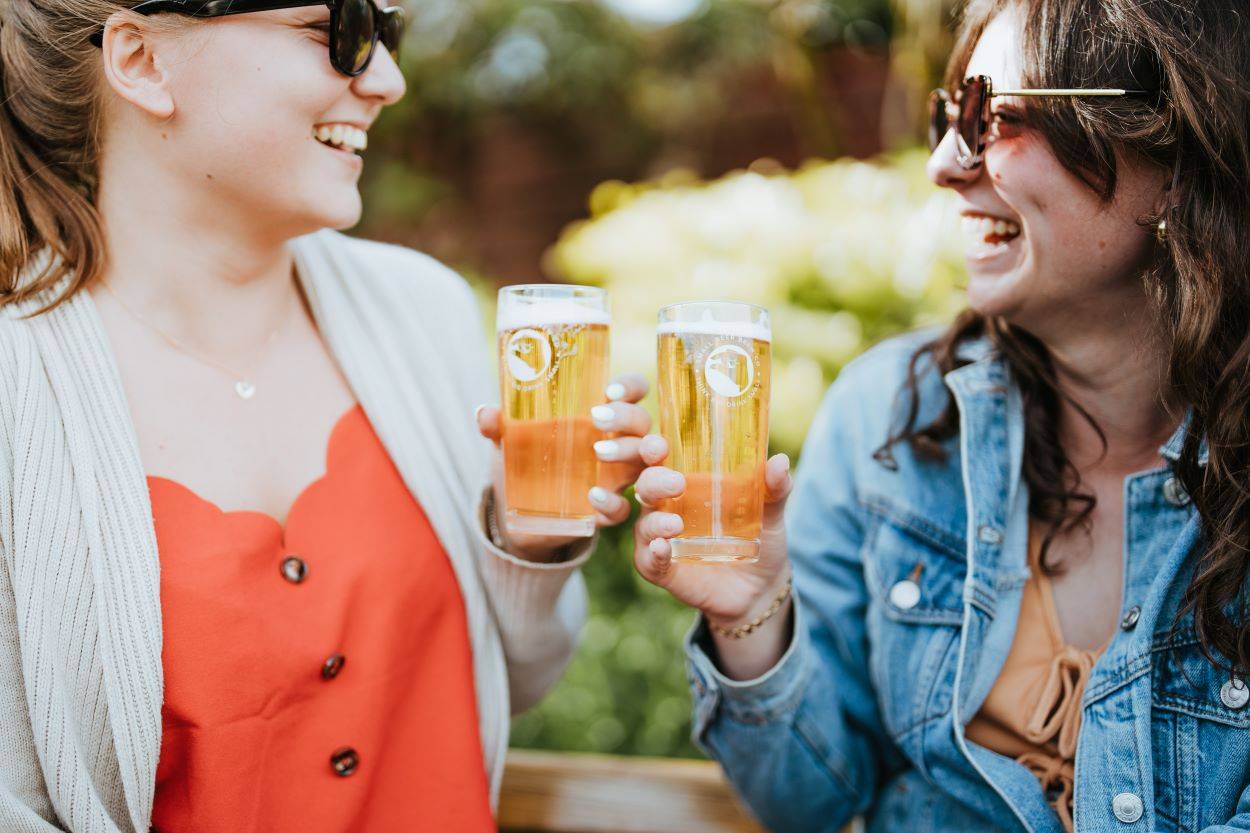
[548,151,964,452]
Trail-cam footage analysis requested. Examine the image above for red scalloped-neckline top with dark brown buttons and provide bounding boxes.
[148,405,495,833]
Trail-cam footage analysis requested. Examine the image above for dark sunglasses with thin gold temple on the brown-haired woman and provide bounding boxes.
[929,75,1149,170]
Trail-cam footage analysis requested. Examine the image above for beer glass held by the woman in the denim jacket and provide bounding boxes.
[659,301,773,562]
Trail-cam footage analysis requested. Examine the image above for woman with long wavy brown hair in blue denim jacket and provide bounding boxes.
[636,0,1250,833]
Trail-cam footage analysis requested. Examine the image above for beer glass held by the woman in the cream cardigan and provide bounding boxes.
[496,284,610,537]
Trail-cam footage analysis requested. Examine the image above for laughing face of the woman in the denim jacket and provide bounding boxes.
[929,6,1165,340]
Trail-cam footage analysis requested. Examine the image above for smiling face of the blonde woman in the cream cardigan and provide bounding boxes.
[123,5,404,235]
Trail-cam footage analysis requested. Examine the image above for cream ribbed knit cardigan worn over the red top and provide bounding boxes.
[0,231,590,833]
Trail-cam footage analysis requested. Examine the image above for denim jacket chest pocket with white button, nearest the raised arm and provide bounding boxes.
[863,492,966,745]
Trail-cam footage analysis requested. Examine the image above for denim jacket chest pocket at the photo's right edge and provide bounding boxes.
[1151,630,1250,830]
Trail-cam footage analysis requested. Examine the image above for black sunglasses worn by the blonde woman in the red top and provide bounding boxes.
[91,0,405,78]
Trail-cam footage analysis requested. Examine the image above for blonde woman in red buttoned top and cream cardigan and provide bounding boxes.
[0,0,648,833]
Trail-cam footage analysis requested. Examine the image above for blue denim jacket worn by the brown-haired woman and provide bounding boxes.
[686,331,1250,833]
